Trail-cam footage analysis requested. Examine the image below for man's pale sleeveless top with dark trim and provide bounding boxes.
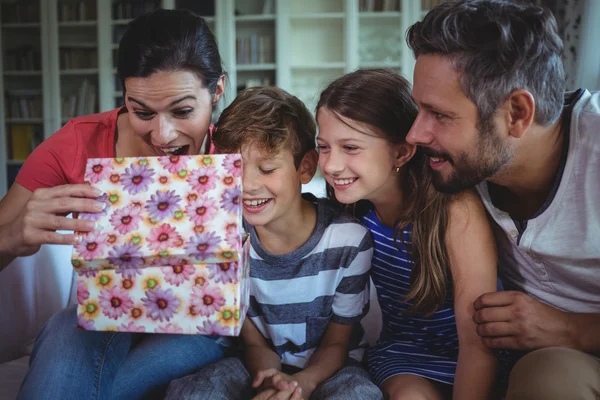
[477,89,600,313]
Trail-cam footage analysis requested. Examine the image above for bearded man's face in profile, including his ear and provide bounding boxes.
[406,55,513,193]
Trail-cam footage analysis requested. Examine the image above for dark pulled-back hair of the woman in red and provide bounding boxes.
[117,9,223,93]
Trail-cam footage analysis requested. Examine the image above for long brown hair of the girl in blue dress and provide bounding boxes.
[316,69,451,316]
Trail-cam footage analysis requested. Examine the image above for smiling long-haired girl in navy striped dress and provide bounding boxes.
[317,70,496,400]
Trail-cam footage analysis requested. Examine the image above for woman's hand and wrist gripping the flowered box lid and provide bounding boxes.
[0,184,106,260]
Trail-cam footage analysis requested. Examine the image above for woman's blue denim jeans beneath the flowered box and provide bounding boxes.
[18,307,225,400]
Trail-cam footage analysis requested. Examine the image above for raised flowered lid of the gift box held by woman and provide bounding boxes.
[72,154,243,271]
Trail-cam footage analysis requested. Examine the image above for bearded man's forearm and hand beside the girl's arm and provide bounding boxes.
[473,291,600,354]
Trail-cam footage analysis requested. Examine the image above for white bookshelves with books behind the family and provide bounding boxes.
[0,0,448,197]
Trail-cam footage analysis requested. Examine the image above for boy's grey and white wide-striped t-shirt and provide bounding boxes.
[246,199,373,368]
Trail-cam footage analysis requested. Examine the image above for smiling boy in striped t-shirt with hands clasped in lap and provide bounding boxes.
[168,87,382,400]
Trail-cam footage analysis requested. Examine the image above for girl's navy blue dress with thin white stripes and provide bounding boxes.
[363,210,458,385]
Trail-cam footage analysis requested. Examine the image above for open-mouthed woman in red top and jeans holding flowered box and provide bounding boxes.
[0,10,224,399]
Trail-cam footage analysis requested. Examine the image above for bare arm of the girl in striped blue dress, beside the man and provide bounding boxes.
[446,191,498,400]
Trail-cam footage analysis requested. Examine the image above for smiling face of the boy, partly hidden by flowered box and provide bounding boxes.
[241,143,314,227]
